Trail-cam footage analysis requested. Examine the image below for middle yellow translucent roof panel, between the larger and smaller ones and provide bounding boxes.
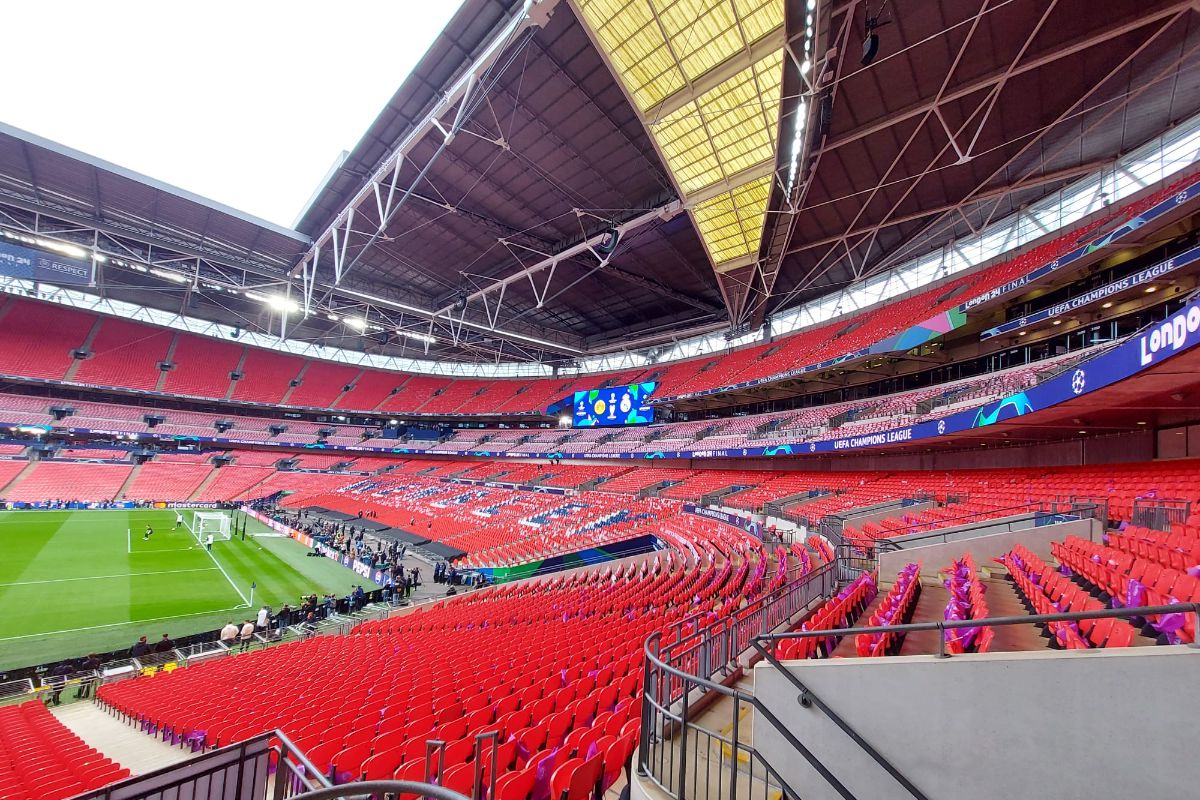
[650,50,784,194]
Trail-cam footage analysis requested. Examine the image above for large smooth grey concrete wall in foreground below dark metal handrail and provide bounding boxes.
[754,646,1200,800]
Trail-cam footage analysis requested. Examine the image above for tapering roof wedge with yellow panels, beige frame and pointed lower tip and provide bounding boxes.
[569,0,822,325]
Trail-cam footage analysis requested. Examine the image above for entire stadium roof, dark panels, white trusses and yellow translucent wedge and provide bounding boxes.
[0,0,1200,362]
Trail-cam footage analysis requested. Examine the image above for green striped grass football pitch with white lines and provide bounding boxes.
[0,509,365,669]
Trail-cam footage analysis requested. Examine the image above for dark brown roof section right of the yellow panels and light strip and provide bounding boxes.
[769,0,1200,316]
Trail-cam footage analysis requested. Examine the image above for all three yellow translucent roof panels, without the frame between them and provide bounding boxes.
[575,0,784,265]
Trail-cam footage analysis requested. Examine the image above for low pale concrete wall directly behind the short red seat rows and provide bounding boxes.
[878,517,1104,581]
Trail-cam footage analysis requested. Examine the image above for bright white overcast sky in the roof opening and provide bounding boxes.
[0,0,461,227]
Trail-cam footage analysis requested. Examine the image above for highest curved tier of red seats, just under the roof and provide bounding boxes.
[0,167,1195,415]
